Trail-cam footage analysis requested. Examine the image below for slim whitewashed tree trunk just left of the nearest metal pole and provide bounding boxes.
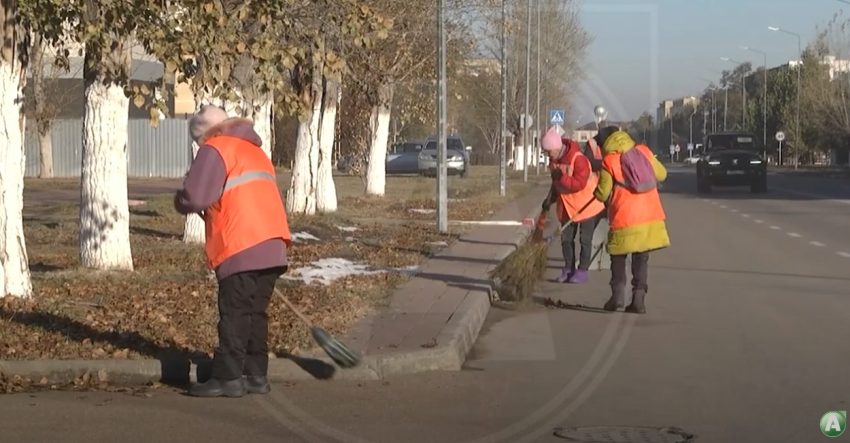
[366,84,393,196]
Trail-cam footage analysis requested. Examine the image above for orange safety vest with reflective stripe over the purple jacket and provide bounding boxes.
[204,135,291,269]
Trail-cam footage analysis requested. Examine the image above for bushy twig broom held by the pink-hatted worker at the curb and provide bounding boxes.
[490,199,593,302]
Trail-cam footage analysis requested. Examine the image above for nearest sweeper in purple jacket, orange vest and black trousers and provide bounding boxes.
[174,106,291,397]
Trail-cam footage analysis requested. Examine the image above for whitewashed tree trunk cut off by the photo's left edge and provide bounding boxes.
[0,54,32,297]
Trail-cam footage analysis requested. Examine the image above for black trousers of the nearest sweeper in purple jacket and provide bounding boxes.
[212,268,284,380]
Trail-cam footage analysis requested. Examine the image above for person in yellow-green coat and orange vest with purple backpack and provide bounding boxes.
[594,130,670,314]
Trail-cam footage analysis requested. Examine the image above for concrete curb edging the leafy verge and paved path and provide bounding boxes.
[0,189,541,385]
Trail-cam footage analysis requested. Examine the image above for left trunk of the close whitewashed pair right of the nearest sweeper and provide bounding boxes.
[286,68,322,215]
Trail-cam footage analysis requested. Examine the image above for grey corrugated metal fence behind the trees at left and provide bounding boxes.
[26,119,191,177]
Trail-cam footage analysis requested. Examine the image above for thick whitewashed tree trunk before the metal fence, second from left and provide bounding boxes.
[80,44,133,270]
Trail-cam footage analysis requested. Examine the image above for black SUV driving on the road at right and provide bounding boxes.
[697,132,767,193]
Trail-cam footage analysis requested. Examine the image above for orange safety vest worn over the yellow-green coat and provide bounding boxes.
[602,145,666,231]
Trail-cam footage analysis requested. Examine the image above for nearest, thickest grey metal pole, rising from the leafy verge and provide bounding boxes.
[437,0,449,233]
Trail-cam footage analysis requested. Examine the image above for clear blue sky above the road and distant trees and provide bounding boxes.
[569,0,850,124]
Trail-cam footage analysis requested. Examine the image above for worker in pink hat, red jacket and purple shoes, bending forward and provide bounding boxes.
[542,127,605,284]
